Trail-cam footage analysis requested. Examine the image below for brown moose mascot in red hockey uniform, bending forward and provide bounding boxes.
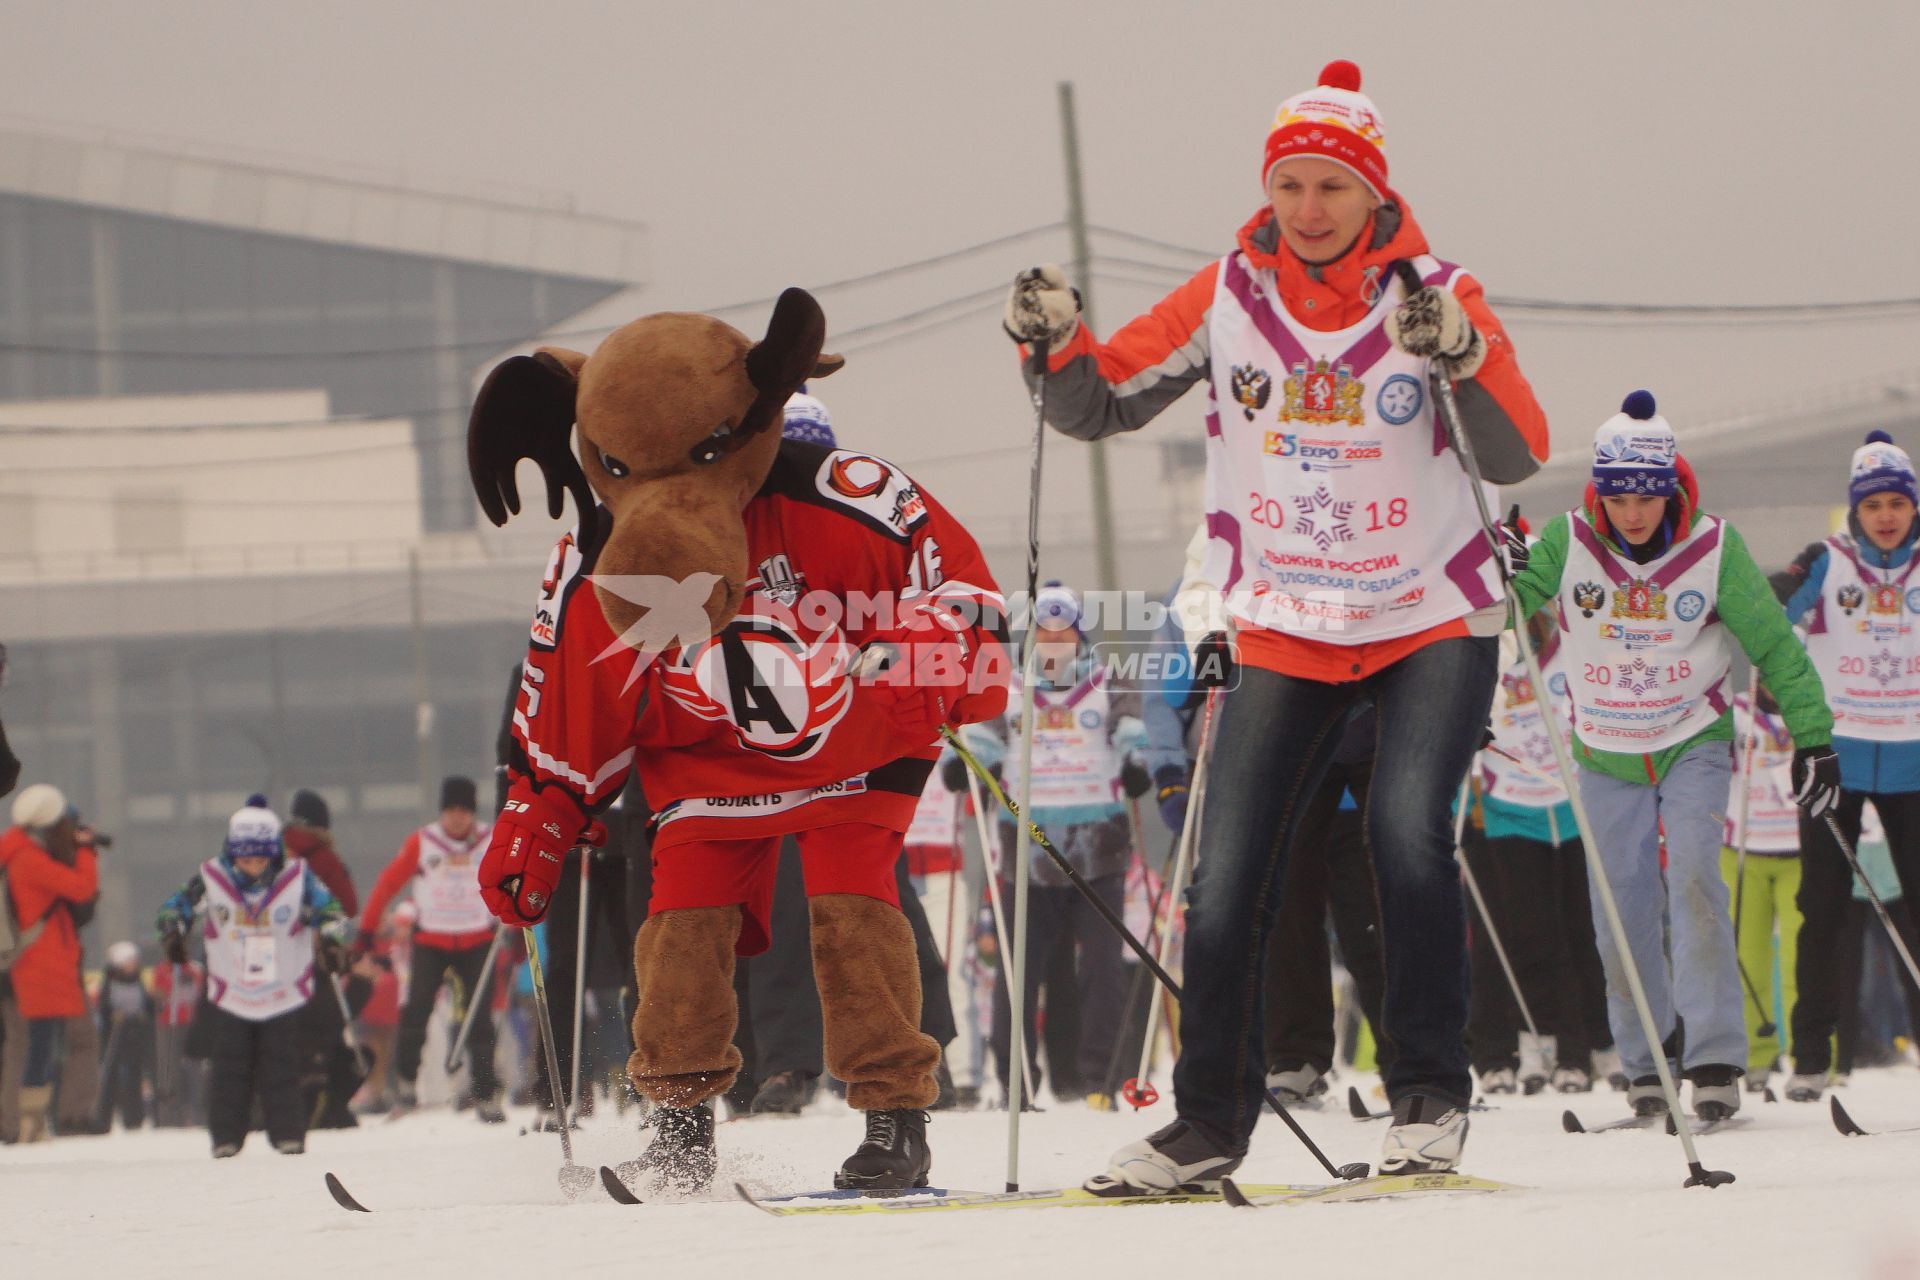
[468,290,1006,1194]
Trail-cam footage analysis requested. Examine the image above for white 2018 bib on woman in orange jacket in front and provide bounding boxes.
[1202,253,1501,645]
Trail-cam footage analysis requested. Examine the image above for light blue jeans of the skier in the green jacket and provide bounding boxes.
[1574,743,1747,1080]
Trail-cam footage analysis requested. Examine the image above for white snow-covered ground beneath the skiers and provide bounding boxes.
[11,1069,1920,1280]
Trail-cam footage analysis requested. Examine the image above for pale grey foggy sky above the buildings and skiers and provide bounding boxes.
[0,0,1920,570]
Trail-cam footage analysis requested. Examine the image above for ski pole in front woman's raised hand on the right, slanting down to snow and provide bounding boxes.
[1420,320,1734,1188]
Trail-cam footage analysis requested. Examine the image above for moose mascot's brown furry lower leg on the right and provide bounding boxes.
[806,894,941,1111]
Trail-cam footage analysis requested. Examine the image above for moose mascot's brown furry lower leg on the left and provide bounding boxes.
[626,906,741,1107]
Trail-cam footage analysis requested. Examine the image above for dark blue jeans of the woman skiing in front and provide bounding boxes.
[1173,637,1498,1148]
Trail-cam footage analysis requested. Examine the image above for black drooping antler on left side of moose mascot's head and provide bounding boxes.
[467,347,593,524]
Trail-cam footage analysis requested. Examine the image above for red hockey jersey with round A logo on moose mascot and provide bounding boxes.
[511,441,1008,846]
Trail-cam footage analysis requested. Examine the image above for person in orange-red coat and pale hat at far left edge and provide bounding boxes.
[0,783,100,1142]
